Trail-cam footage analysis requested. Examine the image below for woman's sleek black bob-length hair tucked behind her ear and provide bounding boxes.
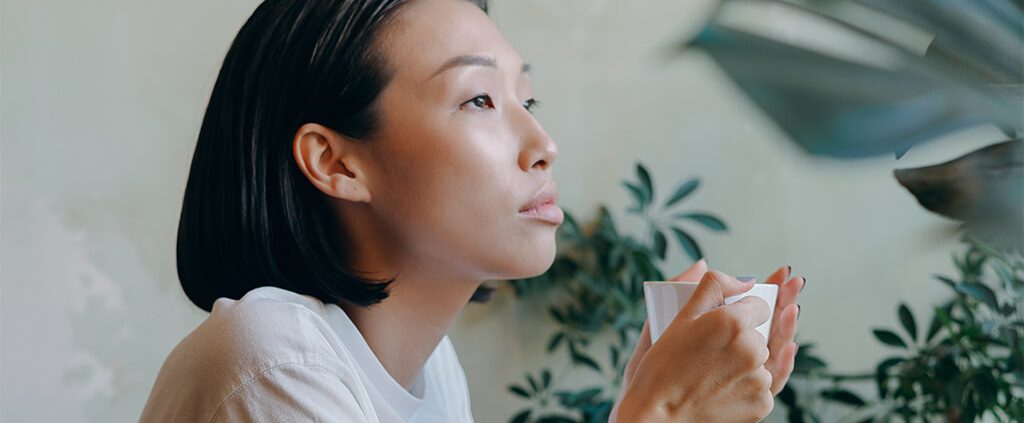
[177,0,487,311]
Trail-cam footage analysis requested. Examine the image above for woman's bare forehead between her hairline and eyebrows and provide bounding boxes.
[382,0,521,80]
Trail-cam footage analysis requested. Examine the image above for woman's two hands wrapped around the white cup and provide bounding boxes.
[611,266,804,422]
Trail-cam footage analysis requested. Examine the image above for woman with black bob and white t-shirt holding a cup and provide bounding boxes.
[141,0,804,422]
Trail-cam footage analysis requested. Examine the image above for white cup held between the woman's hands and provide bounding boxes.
[643,281,778,342]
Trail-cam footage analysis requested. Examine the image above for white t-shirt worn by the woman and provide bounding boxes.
[139,287,473,423]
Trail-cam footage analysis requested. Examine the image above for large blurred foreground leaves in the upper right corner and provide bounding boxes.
[683,0,1024,250]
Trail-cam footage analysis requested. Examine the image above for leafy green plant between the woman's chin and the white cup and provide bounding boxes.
[508,163,727,423]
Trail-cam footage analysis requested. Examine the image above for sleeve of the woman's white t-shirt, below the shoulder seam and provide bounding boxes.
[210,363,376,423]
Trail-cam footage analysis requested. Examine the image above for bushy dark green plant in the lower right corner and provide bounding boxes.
[780,241,1024,422]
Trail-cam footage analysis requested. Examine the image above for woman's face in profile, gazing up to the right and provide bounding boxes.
[354,0,561,281]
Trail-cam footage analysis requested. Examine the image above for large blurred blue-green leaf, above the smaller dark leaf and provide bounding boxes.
[689,11,1024,158]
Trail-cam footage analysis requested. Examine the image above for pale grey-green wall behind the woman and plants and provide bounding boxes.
[0,0,1020,423]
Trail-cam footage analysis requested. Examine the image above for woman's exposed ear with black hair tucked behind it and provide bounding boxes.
[292,123,370,203]
